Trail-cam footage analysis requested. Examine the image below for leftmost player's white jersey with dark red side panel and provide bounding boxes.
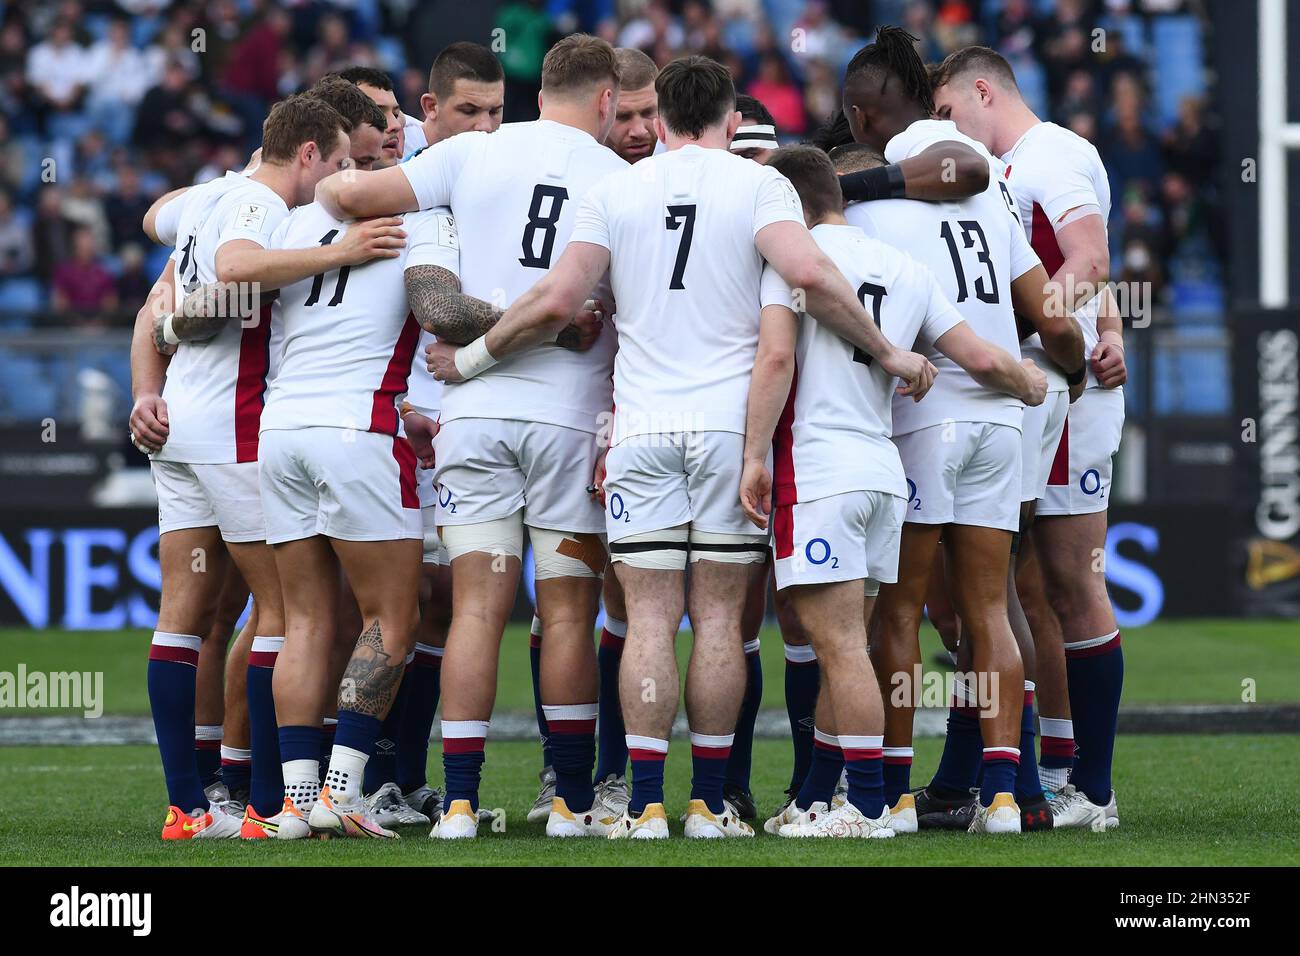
[153,173,289,464]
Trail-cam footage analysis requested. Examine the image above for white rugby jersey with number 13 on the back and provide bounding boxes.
[844,120,1039,434]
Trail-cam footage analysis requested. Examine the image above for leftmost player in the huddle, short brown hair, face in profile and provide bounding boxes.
[135,96,348,838]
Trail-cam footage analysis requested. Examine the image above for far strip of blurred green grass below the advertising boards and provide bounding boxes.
[0,620,1300,715]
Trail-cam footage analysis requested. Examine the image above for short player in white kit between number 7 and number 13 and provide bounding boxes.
[740,146,1047,838]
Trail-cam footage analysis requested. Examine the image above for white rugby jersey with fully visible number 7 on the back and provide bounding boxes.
[569,146,803,442]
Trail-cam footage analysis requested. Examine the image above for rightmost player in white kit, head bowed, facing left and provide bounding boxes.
[933,47,1127,830]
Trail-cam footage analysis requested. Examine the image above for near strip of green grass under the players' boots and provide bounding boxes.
[0,736,1300,866]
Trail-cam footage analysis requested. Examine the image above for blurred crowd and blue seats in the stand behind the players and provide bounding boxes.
[0,0,1216,434]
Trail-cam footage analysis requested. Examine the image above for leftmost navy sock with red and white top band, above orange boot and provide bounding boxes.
[147,631,208,813]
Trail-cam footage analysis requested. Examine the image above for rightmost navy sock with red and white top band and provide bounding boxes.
[1065,631,1125,806]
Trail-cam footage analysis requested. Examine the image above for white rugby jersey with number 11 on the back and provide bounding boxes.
[261,203,455,436]
